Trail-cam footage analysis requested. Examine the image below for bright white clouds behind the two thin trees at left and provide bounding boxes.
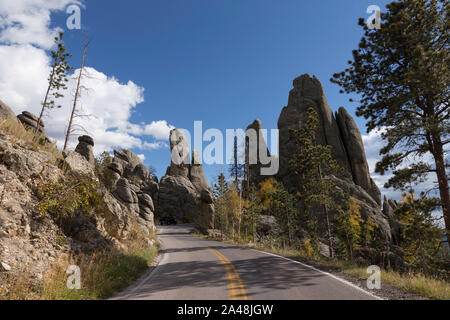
[0,0,173,154]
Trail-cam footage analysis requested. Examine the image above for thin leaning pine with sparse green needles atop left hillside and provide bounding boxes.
[34,32,72,134]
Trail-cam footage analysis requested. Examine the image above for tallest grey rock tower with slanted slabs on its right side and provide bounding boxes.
[278,74,381,204]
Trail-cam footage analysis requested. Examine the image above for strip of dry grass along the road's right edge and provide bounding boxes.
[195,234,450,300]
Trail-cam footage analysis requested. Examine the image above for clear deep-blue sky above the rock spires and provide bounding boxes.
[1,0,389,185]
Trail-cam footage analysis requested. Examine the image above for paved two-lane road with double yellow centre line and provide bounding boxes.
[115,225,376,300]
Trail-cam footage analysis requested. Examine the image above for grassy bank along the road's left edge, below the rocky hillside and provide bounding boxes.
[0,231,159,300]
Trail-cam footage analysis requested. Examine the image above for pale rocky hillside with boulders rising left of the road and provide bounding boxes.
[0,99,154,279]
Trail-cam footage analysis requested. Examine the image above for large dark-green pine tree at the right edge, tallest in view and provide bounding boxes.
[331,0,450,233]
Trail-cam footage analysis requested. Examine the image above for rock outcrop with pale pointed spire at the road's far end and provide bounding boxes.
[157,129,214,234]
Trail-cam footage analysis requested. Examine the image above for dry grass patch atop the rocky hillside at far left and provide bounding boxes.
[0,119,60,157]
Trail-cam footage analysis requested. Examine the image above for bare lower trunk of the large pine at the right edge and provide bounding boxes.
[433,135,450,234]
